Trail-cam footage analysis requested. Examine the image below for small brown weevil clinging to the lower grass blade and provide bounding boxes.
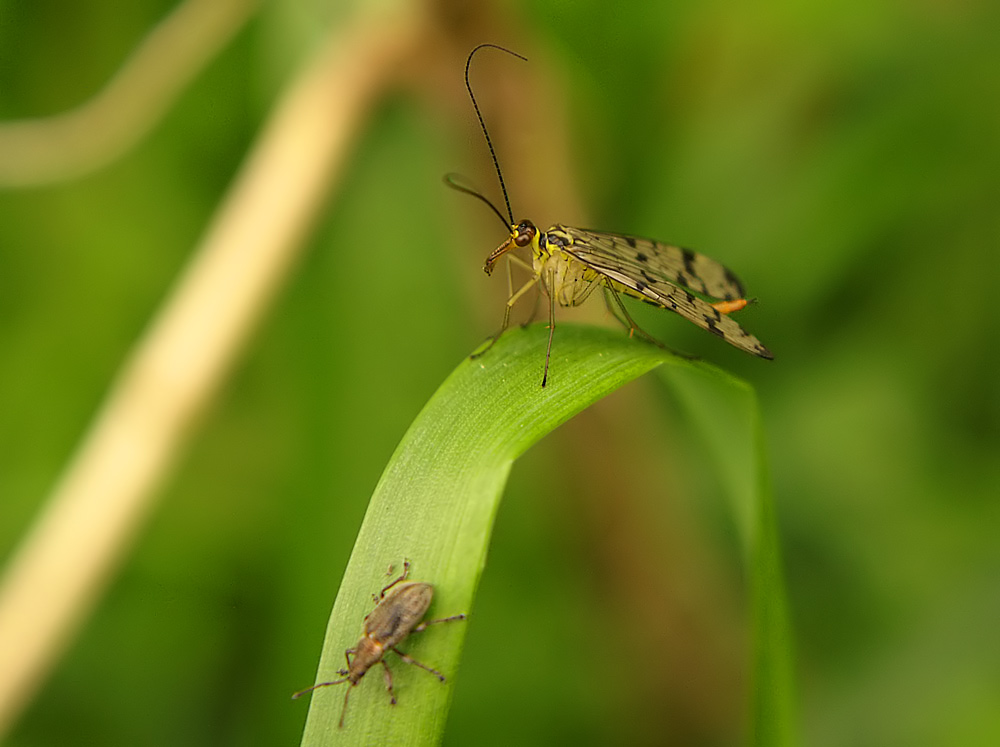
[292,561,465,728]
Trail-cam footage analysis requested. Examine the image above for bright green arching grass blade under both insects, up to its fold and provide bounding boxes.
[302,325,796,747]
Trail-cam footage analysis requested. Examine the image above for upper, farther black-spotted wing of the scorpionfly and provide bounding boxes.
[561,226,744,301]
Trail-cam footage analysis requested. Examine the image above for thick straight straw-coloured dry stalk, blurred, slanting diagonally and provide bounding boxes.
[0,2,421,735]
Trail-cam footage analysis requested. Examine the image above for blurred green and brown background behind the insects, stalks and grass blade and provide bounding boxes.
[0,0,1000,745]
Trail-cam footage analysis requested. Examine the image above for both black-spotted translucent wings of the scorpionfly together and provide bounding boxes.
[559,226,774,359]
